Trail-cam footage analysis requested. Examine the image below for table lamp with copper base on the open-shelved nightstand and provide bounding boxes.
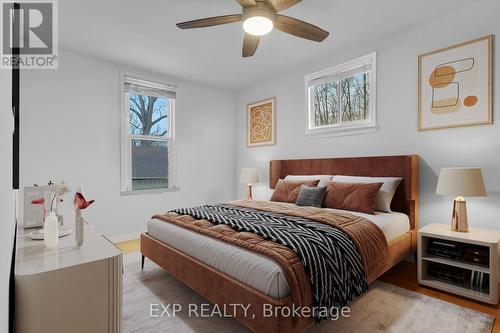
[436,168,486,232]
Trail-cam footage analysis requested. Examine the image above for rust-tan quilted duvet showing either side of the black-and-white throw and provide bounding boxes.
[153,200,388,306]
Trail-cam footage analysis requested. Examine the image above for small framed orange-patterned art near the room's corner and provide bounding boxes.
[247,98,276,147]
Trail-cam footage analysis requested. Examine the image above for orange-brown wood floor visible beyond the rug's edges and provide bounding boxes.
[117,240,500,333]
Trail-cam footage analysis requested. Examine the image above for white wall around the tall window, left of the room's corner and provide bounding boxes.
[21,51,235,236]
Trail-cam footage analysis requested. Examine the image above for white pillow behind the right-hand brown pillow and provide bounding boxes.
[332,176,403,213]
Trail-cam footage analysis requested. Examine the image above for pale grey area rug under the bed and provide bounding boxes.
[123,253,495,333]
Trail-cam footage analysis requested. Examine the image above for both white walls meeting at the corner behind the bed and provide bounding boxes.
[21,0,500,236]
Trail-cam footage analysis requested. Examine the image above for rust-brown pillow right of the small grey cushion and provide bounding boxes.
[323,181,383,215]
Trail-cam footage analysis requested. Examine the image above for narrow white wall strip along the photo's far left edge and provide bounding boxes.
[0,65,15,332]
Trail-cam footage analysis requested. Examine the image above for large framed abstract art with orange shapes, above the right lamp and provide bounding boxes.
[418,35,493,131]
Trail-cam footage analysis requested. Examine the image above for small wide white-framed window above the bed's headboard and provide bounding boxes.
[306,53,376,134]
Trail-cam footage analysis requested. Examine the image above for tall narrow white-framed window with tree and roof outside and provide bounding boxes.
[121,75,176,192]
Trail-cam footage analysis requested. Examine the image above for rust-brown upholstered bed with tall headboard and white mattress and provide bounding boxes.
[141,155,419,332]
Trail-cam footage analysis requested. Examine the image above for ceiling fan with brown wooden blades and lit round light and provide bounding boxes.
[177,0,329,57]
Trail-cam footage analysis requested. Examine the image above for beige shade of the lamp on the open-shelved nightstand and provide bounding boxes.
[436,168,486,197]
